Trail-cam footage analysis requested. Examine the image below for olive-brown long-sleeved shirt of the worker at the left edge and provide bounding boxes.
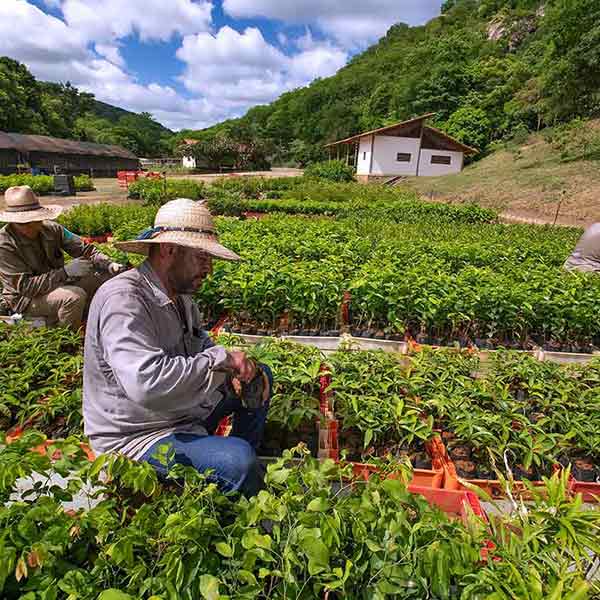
[0,221,110,313]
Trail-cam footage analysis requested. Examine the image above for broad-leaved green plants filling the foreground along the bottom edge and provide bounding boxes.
[0,434,600,600]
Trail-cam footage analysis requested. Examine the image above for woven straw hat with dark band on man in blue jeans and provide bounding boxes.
[114,198,240,260]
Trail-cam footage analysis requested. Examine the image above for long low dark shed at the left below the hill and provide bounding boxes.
[0,131,139,177]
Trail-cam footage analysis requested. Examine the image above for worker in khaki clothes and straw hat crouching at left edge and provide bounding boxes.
[0,186,124,329]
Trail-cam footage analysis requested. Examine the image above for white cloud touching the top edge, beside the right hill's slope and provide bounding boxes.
[223,0,441,48]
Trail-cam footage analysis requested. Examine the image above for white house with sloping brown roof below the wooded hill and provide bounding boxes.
[326,113,477,183]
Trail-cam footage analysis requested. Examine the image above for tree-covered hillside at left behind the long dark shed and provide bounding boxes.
[0,57,172,156]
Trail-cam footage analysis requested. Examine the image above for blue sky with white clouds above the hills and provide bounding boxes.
[0,0,442,129]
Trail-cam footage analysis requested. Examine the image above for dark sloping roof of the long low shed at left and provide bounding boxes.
[0,131,137,160]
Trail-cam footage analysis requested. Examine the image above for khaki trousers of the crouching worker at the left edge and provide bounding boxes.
[24,273,111,329]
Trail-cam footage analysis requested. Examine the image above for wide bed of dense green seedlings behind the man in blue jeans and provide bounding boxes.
[55,206,600,352]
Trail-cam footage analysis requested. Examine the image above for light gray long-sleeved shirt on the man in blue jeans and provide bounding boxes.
[83,261,227,460]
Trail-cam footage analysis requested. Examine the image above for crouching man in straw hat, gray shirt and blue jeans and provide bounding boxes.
[83,198,272,494]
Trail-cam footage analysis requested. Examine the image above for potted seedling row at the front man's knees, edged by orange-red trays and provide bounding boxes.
[0,326,600,496]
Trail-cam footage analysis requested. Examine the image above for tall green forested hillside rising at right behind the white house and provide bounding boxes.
[188,0,600,161]
